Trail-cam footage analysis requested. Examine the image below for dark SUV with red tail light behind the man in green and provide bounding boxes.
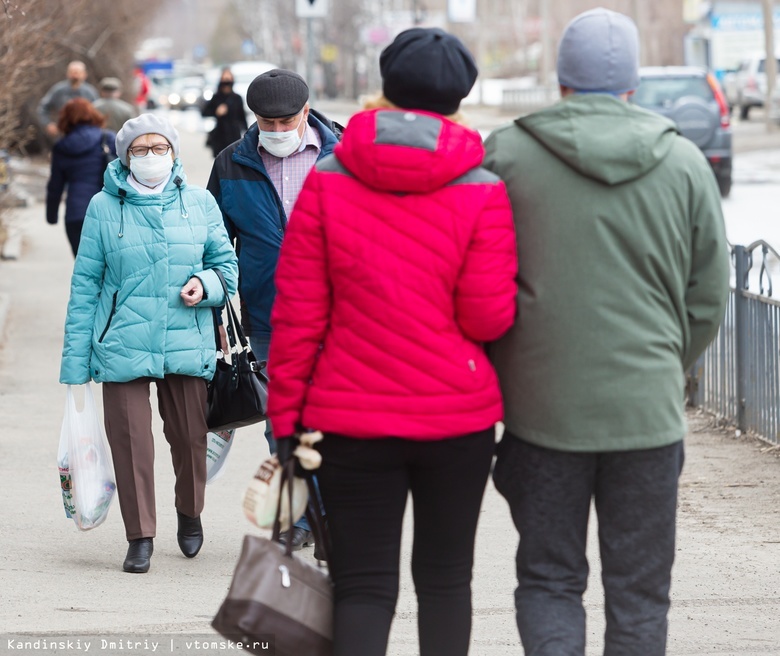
[630,66,732,198]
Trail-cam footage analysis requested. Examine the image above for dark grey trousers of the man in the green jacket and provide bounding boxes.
[493,433,684,656]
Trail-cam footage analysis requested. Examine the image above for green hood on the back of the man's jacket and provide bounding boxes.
[515,94,678,185]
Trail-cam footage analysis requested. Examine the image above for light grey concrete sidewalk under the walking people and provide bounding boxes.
[0,173,780,656]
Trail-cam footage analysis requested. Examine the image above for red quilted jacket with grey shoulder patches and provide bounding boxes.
[269,109,517,440]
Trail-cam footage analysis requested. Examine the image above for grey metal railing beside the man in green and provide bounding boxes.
[688,241,780,444]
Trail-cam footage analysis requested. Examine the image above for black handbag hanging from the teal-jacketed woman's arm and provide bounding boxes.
[206,269,268,431]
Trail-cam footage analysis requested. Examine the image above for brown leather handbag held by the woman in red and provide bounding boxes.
[211,458,333,656]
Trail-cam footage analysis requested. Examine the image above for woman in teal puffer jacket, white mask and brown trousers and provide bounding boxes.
[60,114,238,573]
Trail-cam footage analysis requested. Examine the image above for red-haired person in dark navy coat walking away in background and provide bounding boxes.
[46,98,116,257]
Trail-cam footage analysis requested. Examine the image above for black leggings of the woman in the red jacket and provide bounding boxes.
[318,427,495,656]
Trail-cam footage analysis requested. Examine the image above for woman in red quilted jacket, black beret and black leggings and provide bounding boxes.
[269,28,517,656]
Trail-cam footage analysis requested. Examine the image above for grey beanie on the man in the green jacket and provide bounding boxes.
[558,7,639,94]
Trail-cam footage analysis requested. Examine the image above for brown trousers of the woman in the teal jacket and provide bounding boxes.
[103,375,208,540]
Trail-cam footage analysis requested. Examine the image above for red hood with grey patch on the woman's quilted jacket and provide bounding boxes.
[333,109,485,193]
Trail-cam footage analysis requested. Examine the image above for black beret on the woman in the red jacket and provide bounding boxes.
[379,27,477,116]
